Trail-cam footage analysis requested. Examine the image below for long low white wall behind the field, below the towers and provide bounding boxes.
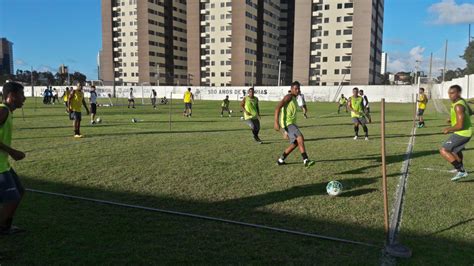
[19,75,474,103]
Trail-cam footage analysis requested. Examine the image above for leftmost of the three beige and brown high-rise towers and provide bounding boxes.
[100,0,188,85]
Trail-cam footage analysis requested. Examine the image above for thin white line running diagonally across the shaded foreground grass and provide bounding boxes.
[26,189,380,248]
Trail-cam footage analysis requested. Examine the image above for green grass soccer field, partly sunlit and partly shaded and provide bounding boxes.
[0,99,474,265]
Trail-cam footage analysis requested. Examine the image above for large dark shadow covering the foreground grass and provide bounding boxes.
[0,178,474,264]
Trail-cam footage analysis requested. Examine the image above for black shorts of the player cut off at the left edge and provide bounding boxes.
[0,169,25,204]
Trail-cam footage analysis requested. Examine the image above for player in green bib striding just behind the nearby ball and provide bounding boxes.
[274,81,315,167]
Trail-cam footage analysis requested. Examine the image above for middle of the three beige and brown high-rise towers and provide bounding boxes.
[187,0,280,86]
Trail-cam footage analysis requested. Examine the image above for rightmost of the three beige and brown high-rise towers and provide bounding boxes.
[293,0,384,85]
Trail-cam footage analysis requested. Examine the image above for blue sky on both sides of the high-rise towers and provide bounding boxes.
[0,0,474,79]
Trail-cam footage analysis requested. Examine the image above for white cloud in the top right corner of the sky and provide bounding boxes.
[428,0,474,24]
